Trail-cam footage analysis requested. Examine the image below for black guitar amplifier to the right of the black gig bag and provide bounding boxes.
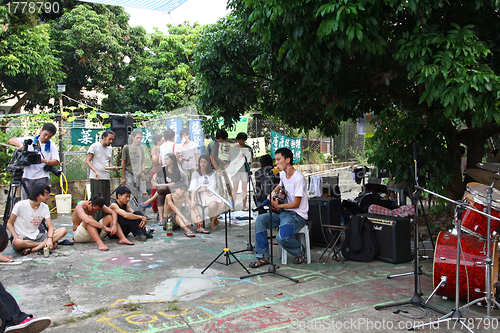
[359,214,411,264]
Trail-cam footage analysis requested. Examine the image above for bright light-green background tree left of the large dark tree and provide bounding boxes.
[104,23,201,112]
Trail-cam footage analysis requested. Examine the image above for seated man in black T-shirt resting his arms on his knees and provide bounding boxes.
[109,185,153,241]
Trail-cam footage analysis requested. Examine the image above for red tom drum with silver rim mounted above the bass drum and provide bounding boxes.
[461,183,500,238]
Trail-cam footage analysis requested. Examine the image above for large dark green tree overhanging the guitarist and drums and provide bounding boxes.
[197,0,500,198]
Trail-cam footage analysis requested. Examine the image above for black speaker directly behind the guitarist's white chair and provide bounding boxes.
[308,197,342,247]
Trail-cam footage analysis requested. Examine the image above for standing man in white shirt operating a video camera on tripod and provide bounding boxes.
[9,123,60,200]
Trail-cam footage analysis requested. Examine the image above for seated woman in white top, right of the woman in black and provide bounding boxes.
[189,155,225,229]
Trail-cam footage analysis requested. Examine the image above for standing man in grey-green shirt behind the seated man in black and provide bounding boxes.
[121,128,147,212]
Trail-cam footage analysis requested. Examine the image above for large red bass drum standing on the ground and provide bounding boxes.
[433,231,498,300]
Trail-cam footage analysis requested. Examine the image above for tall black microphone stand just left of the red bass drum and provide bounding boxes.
[375,143,445,314]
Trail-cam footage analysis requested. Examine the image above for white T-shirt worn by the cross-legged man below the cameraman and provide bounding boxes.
[12,200,50,239]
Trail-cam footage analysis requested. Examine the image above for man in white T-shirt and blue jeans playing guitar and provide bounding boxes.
[250,148,309,268]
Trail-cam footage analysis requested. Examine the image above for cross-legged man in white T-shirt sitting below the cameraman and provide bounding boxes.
[7,183,67,256]
